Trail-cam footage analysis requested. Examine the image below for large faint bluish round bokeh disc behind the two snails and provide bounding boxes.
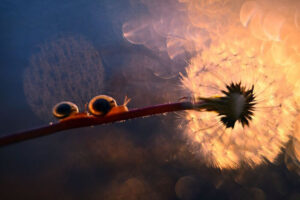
[24,36,104,121]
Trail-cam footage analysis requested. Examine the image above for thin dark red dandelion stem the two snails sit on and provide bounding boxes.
[0,102,200,147]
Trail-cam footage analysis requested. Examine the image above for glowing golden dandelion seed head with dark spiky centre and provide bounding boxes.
[182,45,296,169]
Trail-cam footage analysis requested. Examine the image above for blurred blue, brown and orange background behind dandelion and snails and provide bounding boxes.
[0,0,300,200]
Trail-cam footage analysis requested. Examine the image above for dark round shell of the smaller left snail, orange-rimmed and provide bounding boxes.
[52,101,79,119]
